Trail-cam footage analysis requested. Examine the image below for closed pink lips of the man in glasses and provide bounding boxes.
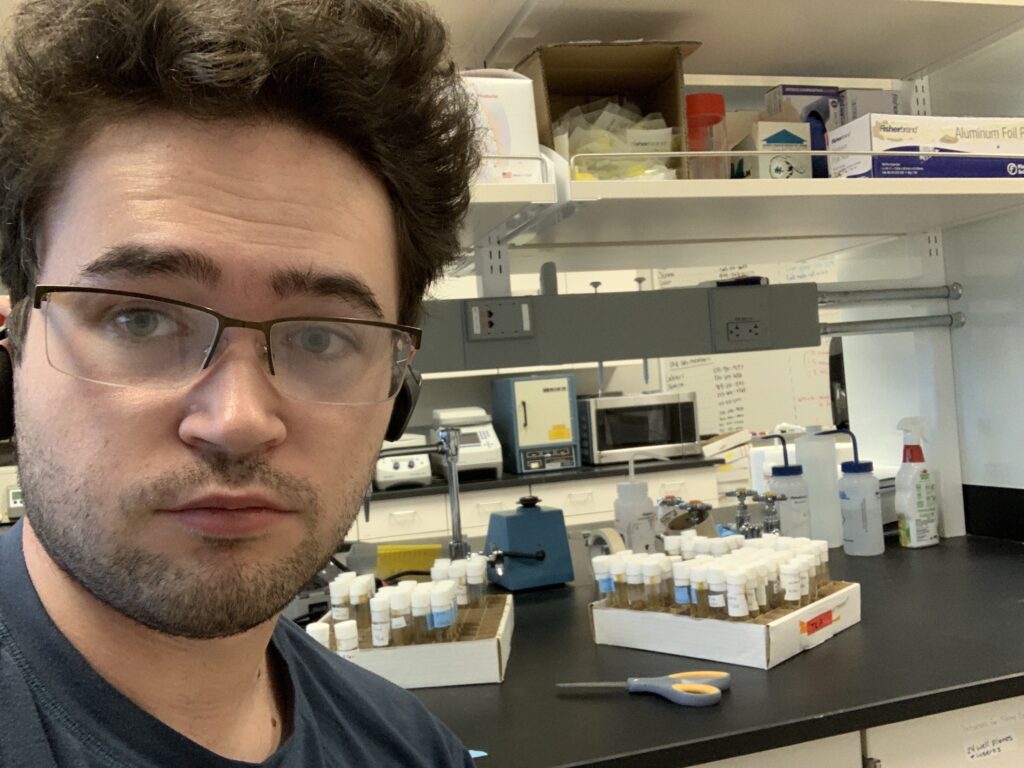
[159,494,295,539]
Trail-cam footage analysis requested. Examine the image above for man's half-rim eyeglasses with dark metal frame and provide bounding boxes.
[33,286,422,406]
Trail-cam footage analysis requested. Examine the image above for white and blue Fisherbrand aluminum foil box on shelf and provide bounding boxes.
[828,114,1024,178]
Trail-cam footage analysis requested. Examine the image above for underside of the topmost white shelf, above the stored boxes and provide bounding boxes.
[477,0,1024,79]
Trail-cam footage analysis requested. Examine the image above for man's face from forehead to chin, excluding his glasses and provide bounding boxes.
[15,114,398,638]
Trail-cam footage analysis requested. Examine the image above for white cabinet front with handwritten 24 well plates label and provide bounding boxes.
[864,696,1024,768]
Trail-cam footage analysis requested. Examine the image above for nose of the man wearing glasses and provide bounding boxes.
[178,329,287,456]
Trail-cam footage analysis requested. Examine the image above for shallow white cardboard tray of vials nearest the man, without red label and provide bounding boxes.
[352,595,515,688]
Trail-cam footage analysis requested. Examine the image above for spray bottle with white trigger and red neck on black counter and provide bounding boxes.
[896,416,939,549]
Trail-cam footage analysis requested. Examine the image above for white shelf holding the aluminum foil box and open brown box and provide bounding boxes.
[514,178,1024,246]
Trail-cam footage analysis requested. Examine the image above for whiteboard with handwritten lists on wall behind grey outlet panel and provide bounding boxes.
[653,256,837,434]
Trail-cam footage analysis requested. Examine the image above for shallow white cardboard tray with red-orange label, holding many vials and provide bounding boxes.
[590,582,860,670]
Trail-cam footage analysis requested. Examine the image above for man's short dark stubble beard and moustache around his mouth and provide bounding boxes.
[18,434,369,639]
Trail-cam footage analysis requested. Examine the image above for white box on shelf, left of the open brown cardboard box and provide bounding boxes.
[462,70,544,183]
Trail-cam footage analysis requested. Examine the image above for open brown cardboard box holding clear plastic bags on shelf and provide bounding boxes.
[515,41,700,165]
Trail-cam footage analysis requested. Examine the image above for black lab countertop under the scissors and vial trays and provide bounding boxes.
[415,532,1024,768]
